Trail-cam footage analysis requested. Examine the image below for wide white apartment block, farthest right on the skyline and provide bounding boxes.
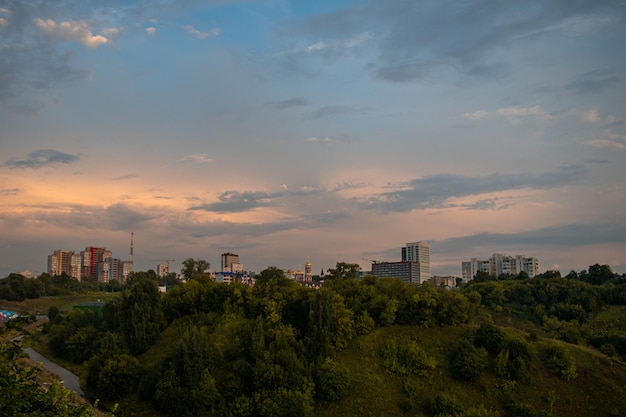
[461,253,539,282]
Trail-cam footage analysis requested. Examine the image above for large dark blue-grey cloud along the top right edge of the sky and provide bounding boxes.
[283,0,624,83]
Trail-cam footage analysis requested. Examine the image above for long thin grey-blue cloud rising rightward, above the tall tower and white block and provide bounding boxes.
[364,165,589,212]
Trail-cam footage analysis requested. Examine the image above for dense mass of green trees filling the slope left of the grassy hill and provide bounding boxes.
[39,264,480,416]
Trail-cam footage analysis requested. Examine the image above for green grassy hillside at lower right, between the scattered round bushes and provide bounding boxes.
[316,316,626,417]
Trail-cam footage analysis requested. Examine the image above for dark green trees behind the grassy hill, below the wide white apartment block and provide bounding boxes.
[464,264,626,361]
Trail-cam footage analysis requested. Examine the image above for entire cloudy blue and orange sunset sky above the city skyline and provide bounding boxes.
[0,0,626,277]
